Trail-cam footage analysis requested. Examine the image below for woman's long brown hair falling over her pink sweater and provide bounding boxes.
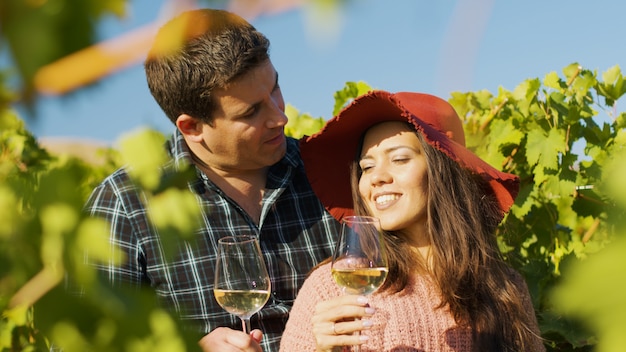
[351,125,536,351]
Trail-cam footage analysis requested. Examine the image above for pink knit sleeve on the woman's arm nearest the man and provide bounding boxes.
[280,264,341,352]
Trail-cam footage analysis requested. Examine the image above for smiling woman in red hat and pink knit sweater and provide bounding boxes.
[281,91,545,352]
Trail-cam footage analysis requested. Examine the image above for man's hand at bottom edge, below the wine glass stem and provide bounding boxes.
[198,327,263,352]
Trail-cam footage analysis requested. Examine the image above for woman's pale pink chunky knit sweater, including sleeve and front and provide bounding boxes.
[280,263,545,352]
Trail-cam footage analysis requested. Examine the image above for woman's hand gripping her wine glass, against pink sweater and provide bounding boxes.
[311,295,375,352]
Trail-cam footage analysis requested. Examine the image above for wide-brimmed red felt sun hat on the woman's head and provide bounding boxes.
[300,91,519,220]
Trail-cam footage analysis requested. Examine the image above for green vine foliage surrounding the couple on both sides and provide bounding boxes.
[0,0,626,352]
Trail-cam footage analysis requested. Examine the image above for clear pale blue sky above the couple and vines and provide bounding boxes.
[22,0,626,143]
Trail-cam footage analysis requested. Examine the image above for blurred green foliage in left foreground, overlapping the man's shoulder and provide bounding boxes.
[0,104,199,351]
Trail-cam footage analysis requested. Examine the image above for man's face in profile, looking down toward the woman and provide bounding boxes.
[198,60,287,173]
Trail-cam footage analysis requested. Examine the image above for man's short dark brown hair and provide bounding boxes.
[144,9,270,123]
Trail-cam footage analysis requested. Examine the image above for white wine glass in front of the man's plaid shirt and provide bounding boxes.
[213,236,271,333]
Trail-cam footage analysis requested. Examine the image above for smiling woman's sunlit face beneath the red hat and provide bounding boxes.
[359,122,428,233]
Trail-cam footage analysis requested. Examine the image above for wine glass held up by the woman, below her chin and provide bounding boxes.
[331,216,388,351]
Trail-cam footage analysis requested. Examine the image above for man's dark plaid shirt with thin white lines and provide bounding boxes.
[87,131,339,351]
